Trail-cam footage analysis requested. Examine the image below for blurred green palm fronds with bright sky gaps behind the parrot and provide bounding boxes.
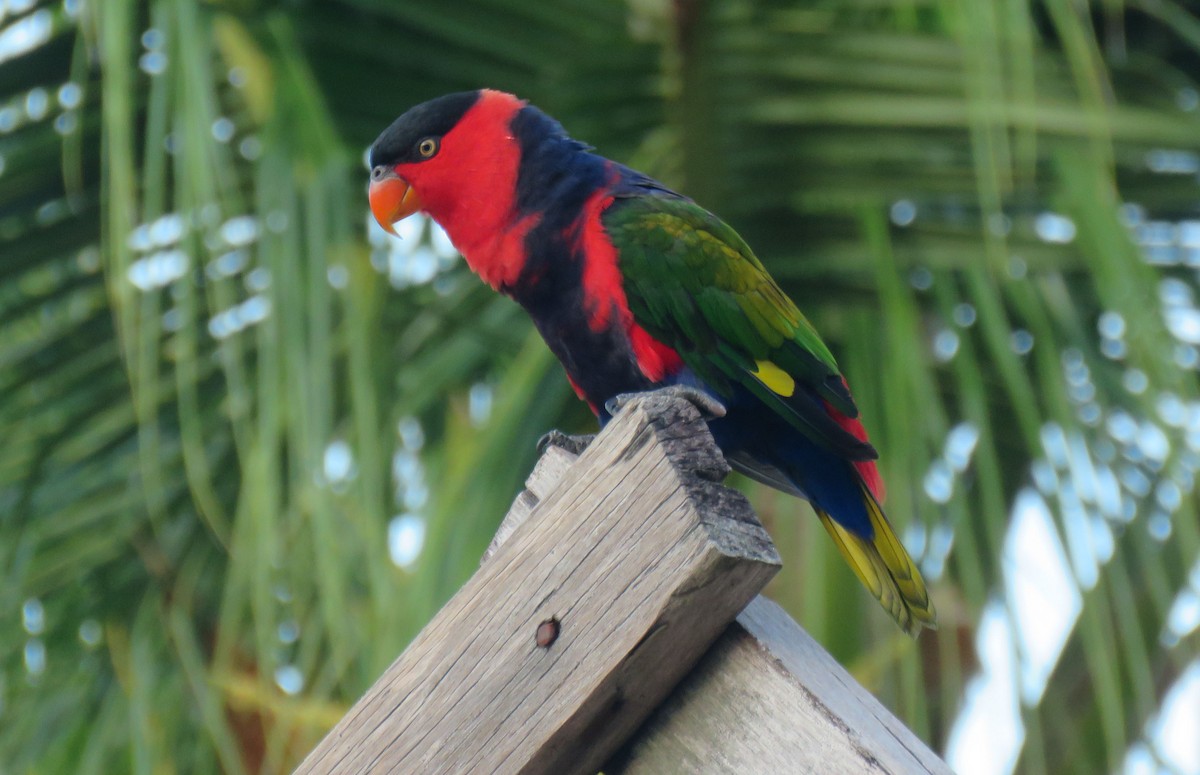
[0,0,1200,773]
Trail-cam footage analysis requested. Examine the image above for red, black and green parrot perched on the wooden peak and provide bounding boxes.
[367,89,937,637]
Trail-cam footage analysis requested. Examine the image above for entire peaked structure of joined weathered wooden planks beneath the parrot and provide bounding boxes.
[296,393,949,775]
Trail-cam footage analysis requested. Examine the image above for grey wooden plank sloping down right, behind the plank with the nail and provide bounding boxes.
[604,597,950,775]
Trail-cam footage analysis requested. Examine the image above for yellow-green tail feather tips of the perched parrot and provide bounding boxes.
[816,485,937,637]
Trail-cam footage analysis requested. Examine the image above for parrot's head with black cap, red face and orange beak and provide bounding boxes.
[368,89,524,234]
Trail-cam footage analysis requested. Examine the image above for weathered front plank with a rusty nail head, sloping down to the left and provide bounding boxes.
[296,396,779,774]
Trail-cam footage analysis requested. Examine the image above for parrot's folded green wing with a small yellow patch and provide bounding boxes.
[602,194,876,459]
